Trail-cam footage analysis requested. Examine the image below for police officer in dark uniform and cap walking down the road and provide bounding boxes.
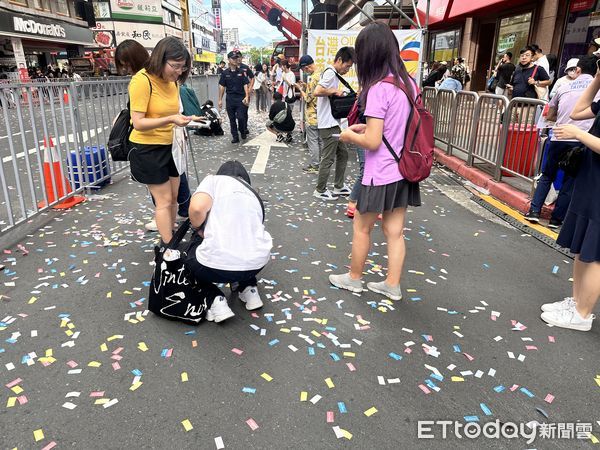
[218,51,250,144]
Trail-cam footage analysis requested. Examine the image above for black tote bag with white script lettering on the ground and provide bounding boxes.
[148,219,224,325]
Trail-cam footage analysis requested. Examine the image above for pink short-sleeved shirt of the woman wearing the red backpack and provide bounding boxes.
[362,81,411,186]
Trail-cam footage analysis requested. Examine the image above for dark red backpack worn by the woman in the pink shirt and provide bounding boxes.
[382,76,434,183]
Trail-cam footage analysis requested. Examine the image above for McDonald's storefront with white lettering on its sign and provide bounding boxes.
[0,0,94,79]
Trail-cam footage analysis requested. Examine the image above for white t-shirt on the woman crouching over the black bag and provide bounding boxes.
[195,175,273,271]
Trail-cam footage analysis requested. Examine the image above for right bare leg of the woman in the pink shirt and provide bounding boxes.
[383,208,406,286]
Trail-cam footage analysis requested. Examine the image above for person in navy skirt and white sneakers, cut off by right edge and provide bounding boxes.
[541,69,600,331]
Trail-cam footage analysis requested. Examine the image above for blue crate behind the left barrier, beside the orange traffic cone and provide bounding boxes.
[67,145,110,189]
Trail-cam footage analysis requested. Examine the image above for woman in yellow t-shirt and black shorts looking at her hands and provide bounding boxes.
[129,37,192,245]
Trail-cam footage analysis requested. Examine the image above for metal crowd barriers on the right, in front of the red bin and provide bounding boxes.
[423,87,546,188]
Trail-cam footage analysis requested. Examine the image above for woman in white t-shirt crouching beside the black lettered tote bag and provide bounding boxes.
[186,161,273,322]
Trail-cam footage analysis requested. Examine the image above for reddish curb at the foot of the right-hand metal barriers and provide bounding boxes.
[434,147,553,217]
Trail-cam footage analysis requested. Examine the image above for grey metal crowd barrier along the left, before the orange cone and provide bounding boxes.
[0,75,218,236]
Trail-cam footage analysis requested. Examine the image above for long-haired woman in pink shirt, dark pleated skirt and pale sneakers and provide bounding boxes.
[329,23,421,300]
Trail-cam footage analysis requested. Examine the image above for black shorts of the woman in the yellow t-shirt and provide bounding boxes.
[129,141,179,184]
